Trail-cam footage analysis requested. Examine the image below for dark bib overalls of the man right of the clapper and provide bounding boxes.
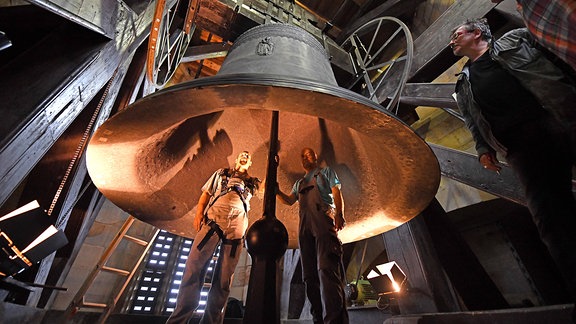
[298,176,348,324]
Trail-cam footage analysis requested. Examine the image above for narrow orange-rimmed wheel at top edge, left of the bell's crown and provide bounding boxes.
[146,0,200,88]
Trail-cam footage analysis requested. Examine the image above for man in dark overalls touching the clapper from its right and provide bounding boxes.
[276,148,348,324]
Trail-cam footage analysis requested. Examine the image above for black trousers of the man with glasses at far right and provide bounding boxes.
[502,117,576,300]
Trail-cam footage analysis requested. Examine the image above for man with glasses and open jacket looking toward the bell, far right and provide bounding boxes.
[449,19,576,316]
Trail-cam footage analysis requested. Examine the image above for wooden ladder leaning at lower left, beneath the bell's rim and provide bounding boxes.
[66,215,159,324]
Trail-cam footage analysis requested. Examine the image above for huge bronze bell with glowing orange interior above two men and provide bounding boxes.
[87,24,440,248]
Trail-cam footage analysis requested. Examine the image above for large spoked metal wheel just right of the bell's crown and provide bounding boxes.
[341,17,414,113]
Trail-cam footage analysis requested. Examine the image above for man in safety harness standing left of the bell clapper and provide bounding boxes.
[166,151,260,324]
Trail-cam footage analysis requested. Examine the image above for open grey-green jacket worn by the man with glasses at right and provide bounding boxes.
[456,28,576,157]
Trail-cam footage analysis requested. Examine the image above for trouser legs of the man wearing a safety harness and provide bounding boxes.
[166,215,243,324]
